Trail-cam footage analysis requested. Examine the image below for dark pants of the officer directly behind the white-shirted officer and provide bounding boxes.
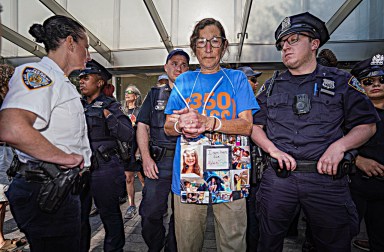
[81,156,125,251]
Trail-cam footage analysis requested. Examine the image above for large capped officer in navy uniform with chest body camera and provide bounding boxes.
[252,12,379,252]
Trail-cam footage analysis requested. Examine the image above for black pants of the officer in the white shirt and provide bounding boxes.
[6,175,80,252]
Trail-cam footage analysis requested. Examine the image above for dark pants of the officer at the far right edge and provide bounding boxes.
[350,173,384,252]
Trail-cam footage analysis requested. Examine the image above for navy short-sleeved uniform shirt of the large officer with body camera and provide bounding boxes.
[254,65,379,160]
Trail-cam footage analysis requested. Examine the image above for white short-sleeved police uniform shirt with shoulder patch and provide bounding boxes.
[2,57,91,166]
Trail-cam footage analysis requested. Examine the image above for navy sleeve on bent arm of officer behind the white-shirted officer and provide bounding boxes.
[106,102,133,142]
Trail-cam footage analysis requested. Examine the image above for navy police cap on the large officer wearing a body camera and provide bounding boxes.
[275,12,329,47]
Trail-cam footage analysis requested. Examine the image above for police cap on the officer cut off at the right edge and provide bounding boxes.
[351,54,384,80]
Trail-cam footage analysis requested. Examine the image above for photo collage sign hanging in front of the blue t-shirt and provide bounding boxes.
[180,133,251,204]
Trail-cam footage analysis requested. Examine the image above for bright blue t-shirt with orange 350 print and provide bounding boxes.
[165,68,260,195]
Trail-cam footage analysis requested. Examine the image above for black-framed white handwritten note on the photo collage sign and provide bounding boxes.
[203,145,232,171]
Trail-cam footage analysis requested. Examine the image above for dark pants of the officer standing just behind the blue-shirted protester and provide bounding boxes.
[139,157,177,251]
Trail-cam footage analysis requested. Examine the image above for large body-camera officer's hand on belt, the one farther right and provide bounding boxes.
[317,144,344,175]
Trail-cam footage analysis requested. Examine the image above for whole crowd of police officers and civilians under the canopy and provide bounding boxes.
[0,6,384,252]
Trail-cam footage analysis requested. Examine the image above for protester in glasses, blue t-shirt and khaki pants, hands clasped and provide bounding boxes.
[164,18,259,252]
